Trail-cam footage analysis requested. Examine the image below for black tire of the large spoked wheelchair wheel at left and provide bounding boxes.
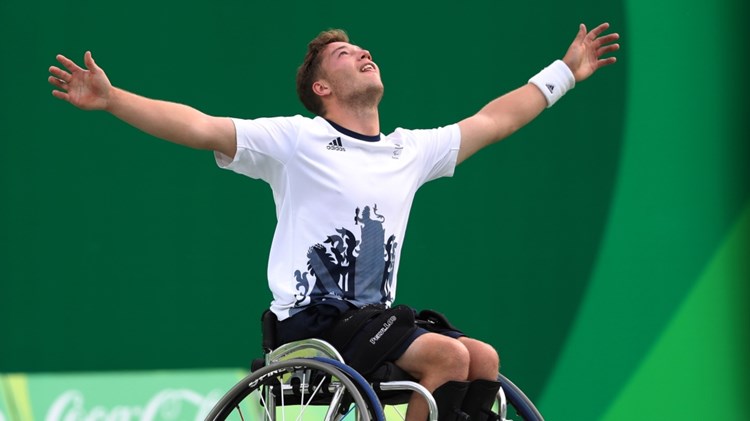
[206,358,372,421]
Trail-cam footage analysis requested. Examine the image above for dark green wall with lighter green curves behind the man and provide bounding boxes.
[0,0,750,420]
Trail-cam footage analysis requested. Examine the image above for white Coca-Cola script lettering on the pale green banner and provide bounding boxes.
[44,389,222,421]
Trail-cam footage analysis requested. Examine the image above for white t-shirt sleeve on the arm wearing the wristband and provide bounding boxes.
[408,124,461,184]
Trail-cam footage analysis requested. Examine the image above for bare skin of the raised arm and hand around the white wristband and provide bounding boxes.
[458,23,620,163]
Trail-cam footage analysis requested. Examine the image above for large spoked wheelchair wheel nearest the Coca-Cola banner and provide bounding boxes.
[206,358,378,421]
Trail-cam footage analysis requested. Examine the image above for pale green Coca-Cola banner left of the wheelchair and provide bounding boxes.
[0,369,253,421]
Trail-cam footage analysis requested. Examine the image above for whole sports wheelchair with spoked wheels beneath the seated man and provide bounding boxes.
[206,310,543,421]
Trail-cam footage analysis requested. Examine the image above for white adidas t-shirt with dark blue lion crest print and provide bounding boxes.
[216,115,461,320]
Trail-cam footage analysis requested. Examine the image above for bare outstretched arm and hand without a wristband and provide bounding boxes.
[48,52,237,157]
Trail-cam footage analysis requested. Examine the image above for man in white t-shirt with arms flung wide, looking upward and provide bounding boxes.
[49,23,619,420]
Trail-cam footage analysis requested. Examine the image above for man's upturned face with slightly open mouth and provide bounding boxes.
[320,42,383,105]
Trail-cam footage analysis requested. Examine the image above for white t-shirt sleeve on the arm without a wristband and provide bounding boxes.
[214,116,304,181]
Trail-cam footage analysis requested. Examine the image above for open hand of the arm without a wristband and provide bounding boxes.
[48,51,112,110]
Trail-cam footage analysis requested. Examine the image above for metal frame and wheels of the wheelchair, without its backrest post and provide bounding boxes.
[206,339,543,421]
